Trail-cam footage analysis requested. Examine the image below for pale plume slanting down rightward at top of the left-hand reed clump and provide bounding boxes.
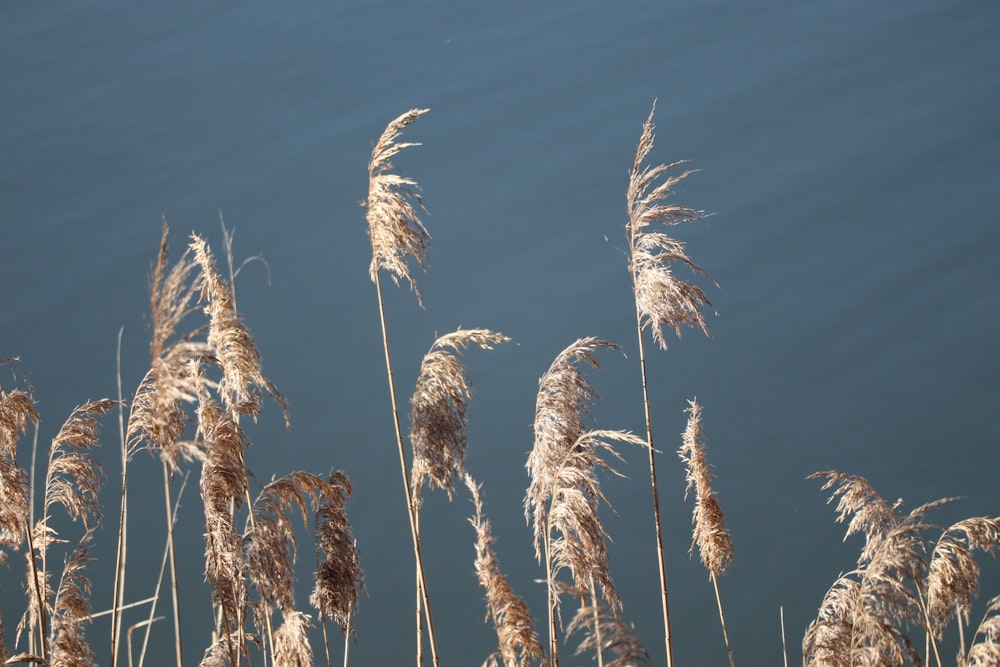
[189,234,288,425]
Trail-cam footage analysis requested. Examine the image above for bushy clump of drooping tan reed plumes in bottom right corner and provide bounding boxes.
[803,471,1000,665]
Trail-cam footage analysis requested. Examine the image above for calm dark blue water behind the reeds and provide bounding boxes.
[0,1,1000,666]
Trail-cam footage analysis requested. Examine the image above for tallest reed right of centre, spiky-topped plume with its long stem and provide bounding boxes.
[626,101,711,667]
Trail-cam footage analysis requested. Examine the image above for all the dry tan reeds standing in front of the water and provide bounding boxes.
[0,105,1000,667]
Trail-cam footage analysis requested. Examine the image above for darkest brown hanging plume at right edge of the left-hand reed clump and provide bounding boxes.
[309,471,365,635]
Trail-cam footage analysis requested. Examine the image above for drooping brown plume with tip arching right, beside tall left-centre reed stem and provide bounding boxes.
[410,329,511,507]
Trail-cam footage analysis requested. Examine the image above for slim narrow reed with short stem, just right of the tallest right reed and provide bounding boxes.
[679,400,735,666]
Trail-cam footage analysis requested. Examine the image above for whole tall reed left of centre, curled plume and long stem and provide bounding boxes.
[363,109,440,667]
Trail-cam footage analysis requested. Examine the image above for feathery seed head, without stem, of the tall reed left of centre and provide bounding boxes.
[364,109,430,306]
